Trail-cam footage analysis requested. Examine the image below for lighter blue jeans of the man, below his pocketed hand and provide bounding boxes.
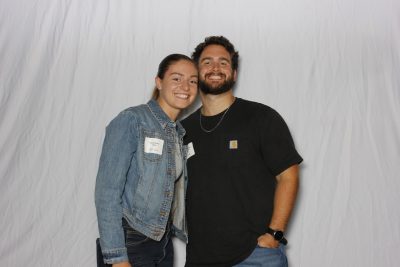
[234,244,288,267]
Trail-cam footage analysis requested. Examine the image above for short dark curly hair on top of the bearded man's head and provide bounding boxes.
[192,36,239,70]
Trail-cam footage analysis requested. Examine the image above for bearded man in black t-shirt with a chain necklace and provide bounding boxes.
[183,36,302,266]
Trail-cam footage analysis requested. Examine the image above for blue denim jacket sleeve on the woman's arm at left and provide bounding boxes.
[95,111,138,264]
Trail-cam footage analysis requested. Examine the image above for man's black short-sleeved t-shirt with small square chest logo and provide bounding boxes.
[183,98,302,266]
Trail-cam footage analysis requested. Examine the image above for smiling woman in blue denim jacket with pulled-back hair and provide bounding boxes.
[95,54,198,267]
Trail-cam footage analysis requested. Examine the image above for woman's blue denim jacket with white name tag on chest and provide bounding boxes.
[95,100,187,264]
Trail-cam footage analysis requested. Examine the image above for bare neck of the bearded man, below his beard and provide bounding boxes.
[200,90,235,116]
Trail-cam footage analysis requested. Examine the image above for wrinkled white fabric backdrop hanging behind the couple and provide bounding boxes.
[0,0,400,267]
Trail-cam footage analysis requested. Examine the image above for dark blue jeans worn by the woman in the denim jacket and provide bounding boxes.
[122,219,174,267]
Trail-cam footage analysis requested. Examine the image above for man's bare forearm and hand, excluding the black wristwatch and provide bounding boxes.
[258,164,299,248]
